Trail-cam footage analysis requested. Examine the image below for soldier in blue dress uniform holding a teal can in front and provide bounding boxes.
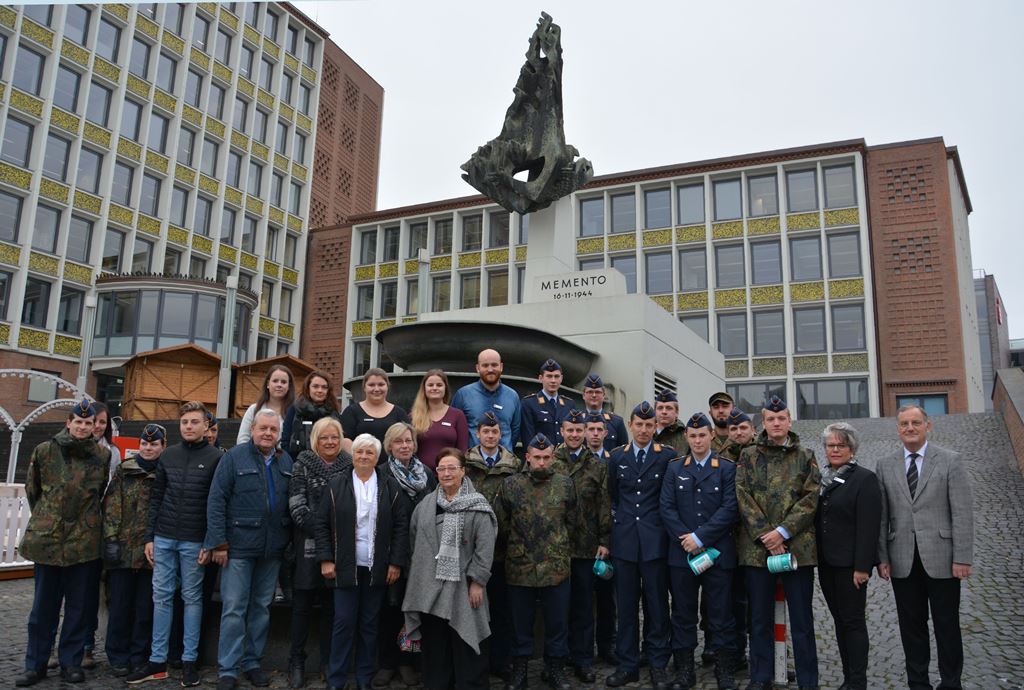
[662,413,739,690]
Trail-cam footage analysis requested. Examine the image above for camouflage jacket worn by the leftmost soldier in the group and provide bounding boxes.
[19,429,111,567]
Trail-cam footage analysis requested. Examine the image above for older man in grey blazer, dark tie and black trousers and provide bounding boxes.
[878,405,974,690]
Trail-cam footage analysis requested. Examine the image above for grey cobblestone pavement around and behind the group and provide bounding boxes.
[0,415,1024,690]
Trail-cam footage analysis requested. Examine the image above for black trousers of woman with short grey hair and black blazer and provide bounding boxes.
[818,564,868,690]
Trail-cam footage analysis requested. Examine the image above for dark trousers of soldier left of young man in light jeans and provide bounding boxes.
[105,568,153,667]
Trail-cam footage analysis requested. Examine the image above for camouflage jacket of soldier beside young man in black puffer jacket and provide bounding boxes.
[103,459,157,569]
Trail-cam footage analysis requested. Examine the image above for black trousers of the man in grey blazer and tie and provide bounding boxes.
[892,547,964,690]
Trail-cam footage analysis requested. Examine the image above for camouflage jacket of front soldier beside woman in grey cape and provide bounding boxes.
[495,472,577,587]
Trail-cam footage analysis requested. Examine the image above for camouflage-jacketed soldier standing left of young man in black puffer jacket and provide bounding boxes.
[103,424,167,678]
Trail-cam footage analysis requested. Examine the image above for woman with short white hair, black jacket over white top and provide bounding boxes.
[315,434,410,690]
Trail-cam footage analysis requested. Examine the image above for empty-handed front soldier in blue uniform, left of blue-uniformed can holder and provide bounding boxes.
[605,400,675,690]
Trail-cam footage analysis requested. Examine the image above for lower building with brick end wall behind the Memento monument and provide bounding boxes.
[333,134,984,419]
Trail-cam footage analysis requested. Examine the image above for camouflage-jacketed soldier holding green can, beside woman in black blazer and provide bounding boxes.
[736,395,821,690]
